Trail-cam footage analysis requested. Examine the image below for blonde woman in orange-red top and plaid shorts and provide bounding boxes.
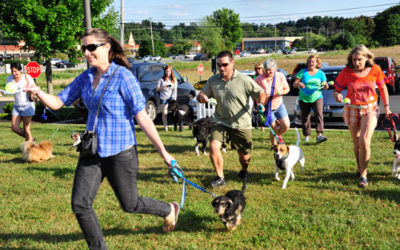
[333,45,392,187]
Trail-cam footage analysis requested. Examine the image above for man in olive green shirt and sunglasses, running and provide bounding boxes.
[197,51,265,187]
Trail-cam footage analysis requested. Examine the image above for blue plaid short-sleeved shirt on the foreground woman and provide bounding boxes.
[58,62,146,157]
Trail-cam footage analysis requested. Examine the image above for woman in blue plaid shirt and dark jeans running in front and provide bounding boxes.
[28,29,179,249]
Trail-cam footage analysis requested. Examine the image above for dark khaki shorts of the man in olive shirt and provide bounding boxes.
[211,124,253,154]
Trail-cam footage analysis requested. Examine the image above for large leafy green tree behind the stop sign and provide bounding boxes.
[0,0,117,93]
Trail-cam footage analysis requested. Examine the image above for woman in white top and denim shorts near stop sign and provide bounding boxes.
[6,63,36,141]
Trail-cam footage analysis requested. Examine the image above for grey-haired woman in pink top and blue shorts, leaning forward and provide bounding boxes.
[256,59,290,146]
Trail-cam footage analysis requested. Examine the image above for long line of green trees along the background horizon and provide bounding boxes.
[125,4,400,56]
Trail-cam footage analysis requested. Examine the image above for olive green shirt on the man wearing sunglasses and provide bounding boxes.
[202,70,264,129]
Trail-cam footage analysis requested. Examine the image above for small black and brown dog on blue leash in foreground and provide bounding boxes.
[211,174,248,231]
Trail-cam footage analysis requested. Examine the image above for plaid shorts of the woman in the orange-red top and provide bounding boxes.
[343,104,379,127]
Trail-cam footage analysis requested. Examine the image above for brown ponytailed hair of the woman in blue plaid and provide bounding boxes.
[83,28,131,69]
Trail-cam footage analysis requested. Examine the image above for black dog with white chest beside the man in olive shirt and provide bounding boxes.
[168,100,194,132]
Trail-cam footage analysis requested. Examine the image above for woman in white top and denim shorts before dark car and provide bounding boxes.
[157,65,178,131]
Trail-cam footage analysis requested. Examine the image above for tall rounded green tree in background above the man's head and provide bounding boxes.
[206,8,242,50]
